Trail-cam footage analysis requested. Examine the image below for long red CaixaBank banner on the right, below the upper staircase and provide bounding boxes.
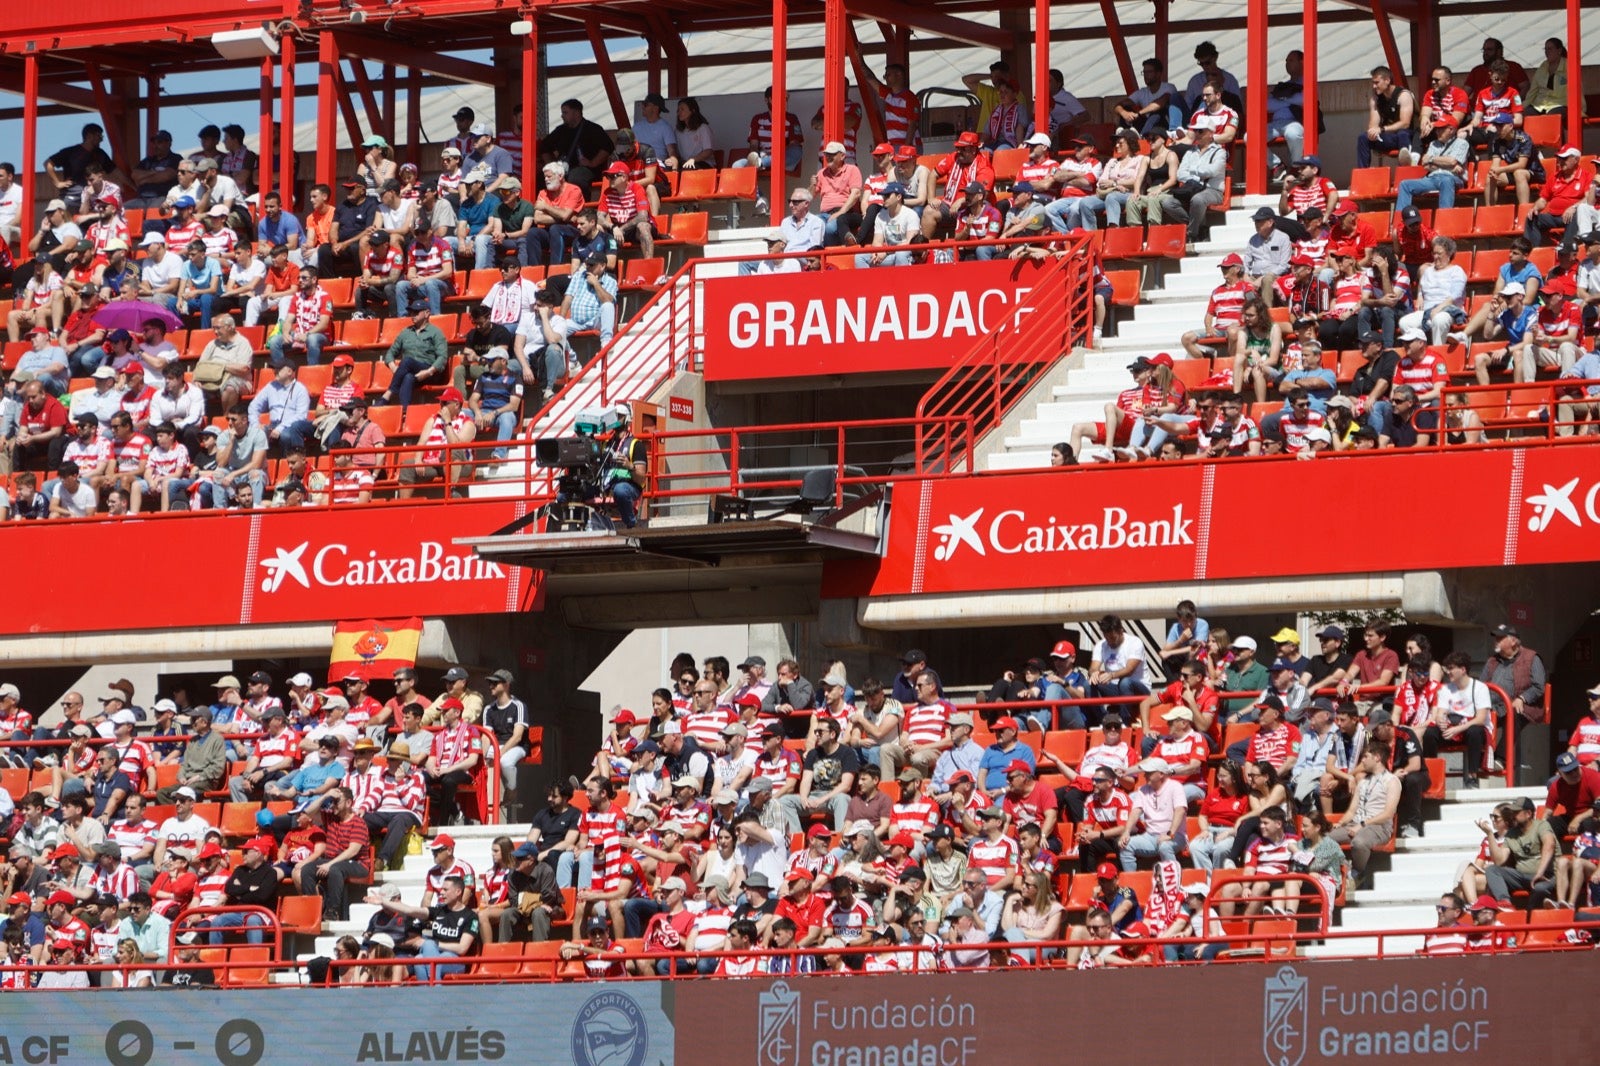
[857,445,1600,597]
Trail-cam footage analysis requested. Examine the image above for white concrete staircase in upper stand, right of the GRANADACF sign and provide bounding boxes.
[989,197,1277,471]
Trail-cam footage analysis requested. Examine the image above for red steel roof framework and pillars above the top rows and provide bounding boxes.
[0,0,1584,219]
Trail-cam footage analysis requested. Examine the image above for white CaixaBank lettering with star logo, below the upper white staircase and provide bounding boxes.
[933,504,1195,562]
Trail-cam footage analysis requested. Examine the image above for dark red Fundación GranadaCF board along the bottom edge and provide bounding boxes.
[674,951,1600,1066]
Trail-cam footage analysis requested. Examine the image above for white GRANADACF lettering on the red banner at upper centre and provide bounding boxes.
[728,287,1032,349]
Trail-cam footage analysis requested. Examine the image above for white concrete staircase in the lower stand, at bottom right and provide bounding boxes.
[1306,777,1544,957]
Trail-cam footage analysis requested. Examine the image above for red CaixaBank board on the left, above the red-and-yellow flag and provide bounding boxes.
[0,499,528,634]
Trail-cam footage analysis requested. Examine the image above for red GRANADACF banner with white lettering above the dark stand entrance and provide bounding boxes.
[704,259,1042,381]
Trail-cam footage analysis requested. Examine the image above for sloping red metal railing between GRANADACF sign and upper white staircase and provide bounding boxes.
[917,234,1096,474]
